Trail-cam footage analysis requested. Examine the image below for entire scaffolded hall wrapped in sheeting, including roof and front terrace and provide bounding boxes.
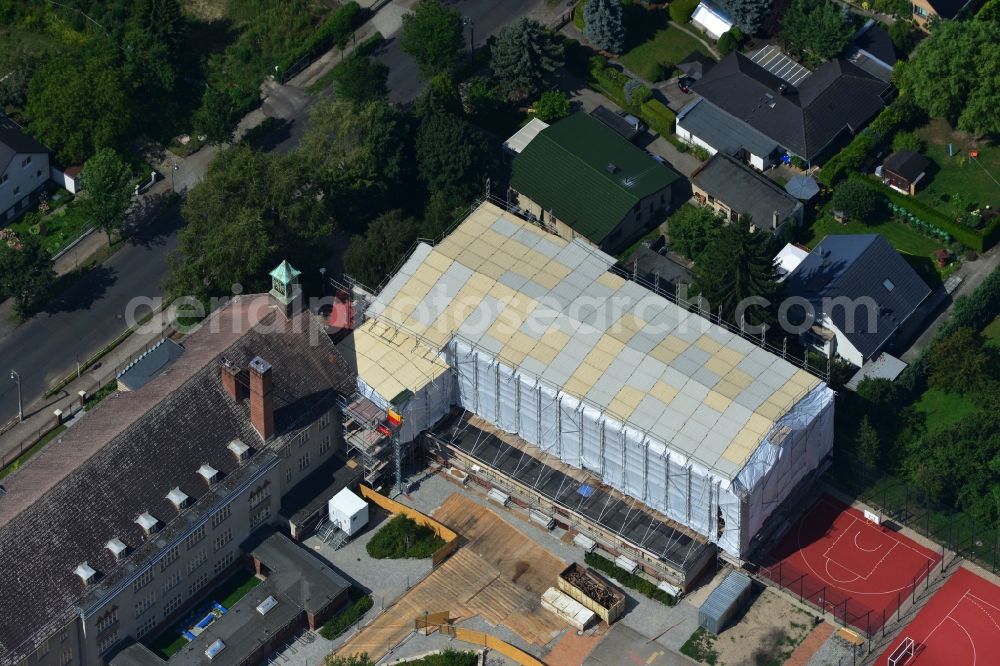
[340,201,834,588]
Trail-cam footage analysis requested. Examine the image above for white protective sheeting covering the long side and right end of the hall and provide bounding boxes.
[448,339,833,557]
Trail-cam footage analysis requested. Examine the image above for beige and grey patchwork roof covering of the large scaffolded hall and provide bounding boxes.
[355,203,820,480]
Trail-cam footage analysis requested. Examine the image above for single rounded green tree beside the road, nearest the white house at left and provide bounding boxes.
[80,148,132,246]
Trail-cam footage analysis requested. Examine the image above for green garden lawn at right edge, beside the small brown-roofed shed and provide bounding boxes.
[916,119,1000,216]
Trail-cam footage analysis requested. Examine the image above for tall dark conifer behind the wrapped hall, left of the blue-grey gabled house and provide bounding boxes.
[694,218,779,325]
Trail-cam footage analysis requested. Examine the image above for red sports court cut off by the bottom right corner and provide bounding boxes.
[875,569,1000,666]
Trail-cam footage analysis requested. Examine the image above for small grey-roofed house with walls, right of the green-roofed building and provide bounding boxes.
[691,153,803,235]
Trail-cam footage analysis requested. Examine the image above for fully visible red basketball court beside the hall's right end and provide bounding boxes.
[762,495,941,632]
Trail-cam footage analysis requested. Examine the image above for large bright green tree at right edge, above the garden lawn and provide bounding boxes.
[899,20,1000,134]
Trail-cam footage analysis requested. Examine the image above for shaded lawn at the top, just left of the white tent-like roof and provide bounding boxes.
[620,3,712,81]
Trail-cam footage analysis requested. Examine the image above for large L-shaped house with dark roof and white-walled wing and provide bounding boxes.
[677,52,893,169]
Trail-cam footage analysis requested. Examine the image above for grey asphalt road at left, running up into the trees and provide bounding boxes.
[0,214,181,422]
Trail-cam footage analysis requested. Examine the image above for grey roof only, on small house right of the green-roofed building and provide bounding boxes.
[691,153,802,230]
